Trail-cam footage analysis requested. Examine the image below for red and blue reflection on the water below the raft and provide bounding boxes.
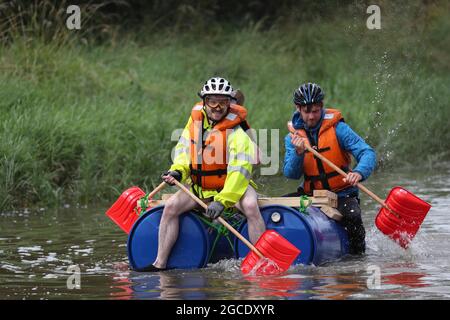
[111,260,386,300]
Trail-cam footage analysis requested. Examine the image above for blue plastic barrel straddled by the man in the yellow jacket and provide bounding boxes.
[128,206,216,269]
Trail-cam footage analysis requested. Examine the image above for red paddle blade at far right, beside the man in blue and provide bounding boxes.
[375,187,431,249]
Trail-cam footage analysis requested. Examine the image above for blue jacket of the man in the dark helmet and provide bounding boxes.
[283,109,376,197]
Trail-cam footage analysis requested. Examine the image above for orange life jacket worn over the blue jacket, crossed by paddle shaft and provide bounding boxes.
[288,109,351,195]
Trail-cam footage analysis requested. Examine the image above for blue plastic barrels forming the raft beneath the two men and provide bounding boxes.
[127,205,348,269]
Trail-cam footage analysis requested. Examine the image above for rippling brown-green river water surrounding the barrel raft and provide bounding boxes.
[0,164,450,300]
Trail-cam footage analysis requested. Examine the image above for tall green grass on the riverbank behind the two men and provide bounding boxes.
[0,1,450,209]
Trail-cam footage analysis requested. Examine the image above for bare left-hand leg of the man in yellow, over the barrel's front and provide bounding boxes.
[153,190,197,268]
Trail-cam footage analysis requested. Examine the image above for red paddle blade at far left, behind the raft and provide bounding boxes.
[106,187,145,234]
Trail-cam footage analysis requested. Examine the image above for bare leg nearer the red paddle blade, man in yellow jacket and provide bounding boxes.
[236,185,266,244]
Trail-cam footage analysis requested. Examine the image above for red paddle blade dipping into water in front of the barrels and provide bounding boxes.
[241,230,300,275]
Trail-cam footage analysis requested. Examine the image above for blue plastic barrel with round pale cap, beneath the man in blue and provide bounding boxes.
[235,205,348,266]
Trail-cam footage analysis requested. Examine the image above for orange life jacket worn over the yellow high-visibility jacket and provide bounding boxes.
[189,103,248,190]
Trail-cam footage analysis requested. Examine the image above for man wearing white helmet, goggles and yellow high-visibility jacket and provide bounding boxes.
[138,77,265,271]
